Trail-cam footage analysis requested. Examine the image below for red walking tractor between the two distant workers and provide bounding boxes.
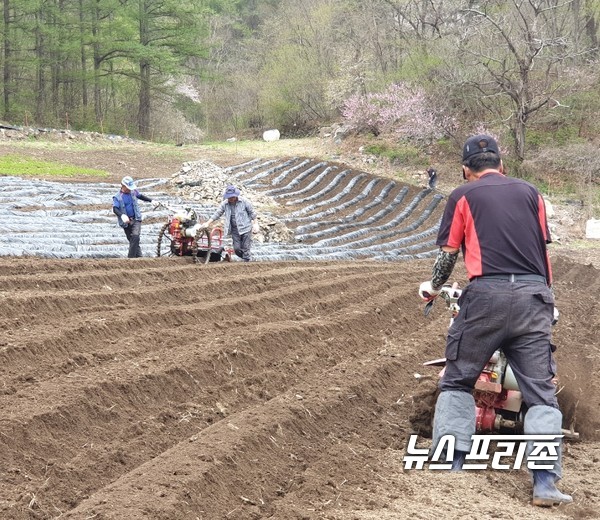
[156,204,233,264]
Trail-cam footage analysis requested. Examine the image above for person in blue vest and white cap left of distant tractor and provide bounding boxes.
[113,177,152,258]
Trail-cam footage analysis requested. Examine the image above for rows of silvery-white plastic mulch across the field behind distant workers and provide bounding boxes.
[0,158,440,261]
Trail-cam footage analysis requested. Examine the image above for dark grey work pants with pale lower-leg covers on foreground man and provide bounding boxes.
[434,279,562,477]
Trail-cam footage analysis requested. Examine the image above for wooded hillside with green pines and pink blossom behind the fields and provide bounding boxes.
[0,0,600,217]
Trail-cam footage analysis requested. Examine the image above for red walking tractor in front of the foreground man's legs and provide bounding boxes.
[424,283,579,440]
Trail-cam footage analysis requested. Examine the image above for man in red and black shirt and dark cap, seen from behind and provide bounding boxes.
[419,135,572,506]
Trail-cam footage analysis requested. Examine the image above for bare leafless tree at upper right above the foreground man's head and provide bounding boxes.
[459,0,593,160]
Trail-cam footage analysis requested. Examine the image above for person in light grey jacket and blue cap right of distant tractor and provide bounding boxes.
[205,185,259,262]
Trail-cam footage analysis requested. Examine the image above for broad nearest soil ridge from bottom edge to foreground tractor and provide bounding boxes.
[65,354,418,520]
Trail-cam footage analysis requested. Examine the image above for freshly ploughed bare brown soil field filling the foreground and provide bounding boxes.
[0,257,600,520]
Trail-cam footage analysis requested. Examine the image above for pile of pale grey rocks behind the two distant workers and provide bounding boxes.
[169,160,294,242]
